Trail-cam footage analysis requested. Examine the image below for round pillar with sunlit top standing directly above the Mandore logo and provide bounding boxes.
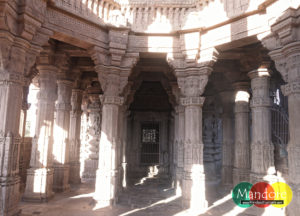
[248,68,275,183]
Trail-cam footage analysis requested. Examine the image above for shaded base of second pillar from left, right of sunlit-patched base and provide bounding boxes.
[53,164,70,192]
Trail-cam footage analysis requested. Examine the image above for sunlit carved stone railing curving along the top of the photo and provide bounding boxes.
[51,0,273,33]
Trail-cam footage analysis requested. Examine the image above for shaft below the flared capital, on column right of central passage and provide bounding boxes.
[181,97,207,210]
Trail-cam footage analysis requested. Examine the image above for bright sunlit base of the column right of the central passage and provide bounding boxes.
[182,172,208,214]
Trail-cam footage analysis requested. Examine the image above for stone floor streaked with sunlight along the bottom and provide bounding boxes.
[20,178,284,216]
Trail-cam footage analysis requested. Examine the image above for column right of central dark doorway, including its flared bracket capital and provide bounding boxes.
[178,67,212,213]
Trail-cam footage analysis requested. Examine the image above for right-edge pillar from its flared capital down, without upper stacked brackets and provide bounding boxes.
[270,43,300,216]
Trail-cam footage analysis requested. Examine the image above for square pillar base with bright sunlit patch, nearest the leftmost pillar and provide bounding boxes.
[22,168,54,202]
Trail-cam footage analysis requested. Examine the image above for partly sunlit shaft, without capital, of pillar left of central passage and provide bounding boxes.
[94,96,123,206]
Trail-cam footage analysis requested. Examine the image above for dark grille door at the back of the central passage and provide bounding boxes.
[141,123,159,164]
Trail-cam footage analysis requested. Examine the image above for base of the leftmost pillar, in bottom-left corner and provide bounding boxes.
[0,176,21,216]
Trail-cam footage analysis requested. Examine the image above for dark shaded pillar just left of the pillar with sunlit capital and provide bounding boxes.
[220,91,234,190]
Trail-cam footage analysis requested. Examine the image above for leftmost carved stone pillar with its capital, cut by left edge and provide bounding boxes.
[0,37,28,216]
